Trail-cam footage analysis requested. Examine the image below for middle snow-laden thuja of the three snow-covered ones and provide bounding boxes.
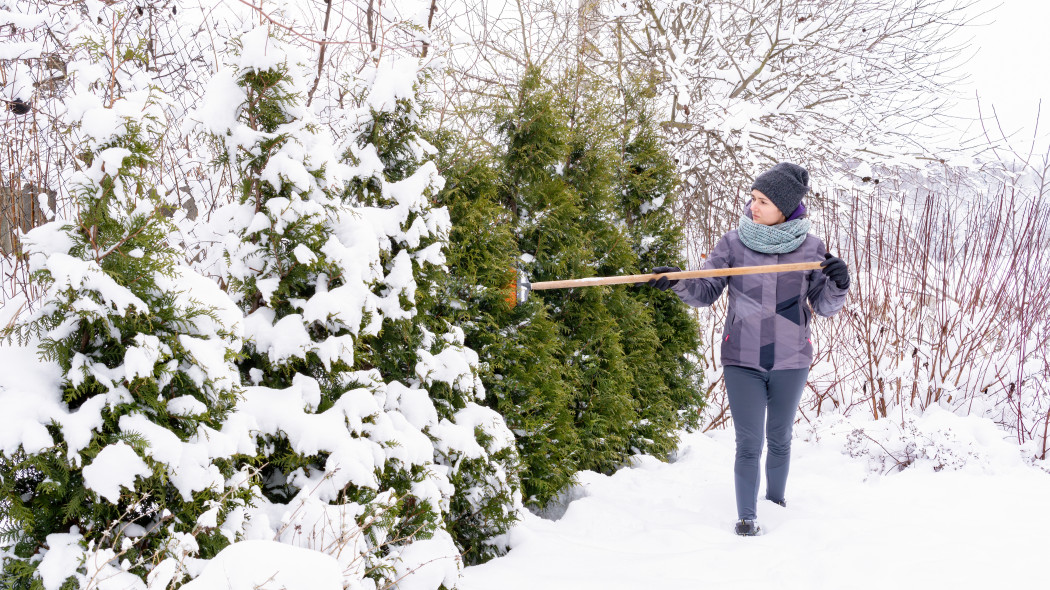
[195,28,512,587]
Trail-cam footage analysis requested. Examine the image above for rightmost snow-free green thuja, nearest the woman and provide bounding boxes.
[566,73,702,457]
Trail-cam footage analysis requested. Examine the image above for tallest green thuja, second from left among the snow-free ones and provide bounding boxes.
[501,68,634,472]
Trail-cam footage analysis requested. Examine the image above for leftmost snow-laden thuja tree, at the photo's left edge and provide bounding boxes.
[0,27,251,590]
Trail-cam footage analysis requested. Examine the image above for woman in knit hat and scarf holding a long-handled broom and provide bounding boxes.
[649,163,849,536]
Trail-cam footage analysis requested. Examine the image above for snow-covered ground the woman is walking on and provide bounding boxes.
[459,424,1050,590]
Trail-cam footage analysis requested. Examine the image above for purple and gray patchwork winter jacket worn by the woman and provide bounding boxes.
[671,211,847,371]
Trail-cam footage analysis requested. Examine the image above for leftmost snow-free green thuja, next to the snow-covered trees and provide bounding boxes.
[439,143,578,508]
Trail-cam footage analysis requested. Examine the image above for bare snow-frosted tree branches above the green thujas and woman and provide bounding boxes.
[438,0,974,255]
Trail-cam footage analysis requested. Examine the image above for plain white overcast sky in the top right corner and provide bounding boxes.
[960,0,1050,152]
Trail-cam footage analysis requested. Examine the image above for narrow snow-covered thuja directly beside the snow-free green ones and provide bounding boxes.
[343,60,521,563]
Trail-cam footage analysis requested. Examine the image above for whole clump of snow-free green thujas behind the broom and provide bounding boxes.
[439,68,702,514]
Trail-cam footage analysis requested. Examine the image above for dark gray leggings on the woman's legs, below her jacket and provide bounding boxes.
[722,365,810,519]
